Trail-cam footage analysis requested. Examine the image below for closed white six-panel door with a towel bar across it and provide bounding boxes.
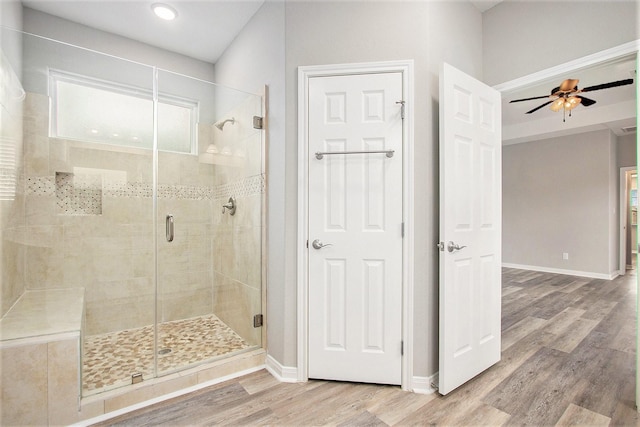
[307,72,404,384]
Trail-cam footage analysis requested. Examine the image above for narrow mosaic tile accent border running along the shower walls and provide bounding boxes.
[26,172,266,200]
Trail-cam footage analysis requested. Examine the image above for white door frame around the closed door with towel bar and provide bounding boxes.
[296,60,414,390]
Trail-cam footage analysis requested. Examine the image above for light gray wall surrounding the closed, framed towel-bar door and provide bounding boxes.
[282,1,482,376]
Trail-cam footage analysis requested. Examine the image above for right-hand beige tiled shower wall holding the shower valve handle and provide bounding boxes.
[208,97,265,345]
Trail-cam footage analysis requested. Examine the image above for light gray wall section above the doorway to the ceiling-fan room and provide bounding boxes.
[482,0,640,85]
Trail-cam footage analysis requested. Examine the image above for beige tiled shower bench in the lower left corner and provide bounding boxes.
[0,288,84,425]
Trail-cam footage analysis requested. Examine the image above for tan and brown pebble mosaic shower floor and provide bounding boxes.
[82,315,252,396]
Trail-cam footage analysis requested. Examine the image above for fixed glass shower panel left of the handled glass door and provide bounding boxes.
[22,34,156,396]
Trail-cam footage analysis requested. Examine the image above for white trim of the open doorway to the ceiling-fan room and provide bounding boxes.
[493,39,640,412]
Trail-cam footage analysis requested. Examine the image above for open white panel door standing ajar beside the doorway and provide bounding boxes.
[438,64,502,394]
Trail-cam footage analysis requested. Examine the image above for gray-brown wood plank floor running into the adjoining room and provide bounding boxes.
[92,269,640,426]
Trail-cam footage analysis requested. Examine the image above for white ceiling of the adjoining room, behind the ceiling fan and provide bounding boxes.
[502,55,636,144]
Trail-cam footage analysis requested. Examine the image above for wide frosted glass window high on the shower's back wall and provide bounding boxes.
[49,70,198,154]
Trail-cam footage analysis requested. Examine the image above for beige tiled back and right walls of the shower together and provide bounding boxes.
[15,93,264,344]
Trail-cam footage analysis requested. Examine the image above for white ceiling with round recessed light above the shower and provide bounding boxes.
[21,0,264,63]
